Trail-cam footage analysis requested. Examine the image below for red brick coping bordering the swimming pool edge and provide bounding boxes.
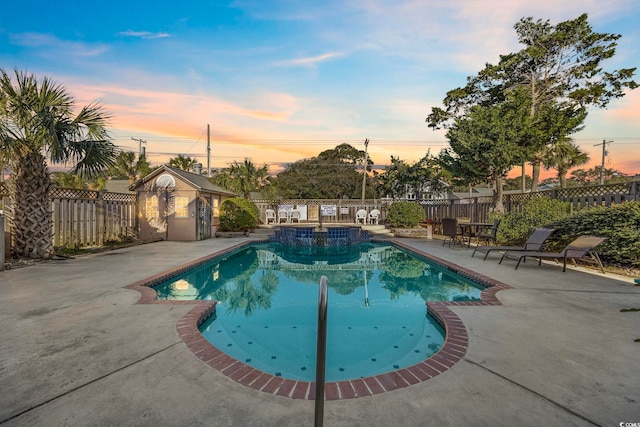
[126,239,510,400]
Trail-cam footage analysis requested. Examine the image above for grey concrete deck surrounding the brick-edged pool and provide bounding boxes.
[0,238,640,426]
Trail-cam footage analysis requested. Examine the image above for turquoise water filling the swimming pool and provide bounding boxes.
[154,243,483,381]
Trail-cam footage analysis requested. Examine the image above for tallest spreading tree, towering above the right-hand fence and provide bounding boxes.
[427,14,638,190]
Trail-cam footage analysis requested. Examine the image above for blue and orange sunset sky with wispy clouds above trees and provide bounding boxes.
[0,0,640,179]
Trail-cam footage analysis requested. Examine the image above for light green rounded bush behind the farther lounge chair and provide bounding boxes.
[492,197,571,245]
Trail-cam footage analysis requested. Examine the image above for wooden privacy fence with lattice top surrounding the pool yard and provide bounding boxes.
[0,181,640,254]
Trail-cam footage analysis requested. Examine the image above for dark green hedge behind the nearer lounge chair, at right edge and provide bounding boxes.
[549,202,640,267]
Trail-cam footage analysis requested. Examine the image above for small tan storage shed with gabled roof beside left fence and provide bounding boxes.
[130,165,235,241]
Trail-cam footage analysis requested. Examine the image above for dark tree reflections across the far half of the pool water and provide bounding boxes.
[155,243,481,316]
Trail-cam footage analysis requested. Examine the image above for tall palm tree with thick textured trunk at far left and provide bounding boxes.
[0,70,115,259]
